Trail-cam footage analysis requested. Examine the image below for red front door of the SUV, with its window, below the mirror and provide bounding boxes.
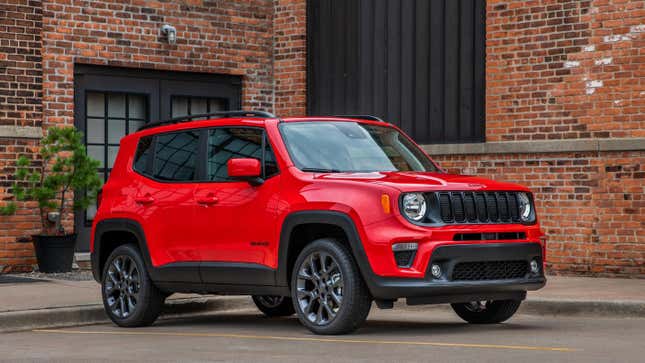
[195,126,280,285]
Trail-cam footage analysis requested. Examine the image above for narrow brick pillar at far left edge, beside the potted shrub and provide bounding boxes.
[0,0,42,272]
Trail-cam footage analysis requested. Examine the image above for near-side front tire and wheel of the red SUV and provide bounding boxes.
[291,238,372,335]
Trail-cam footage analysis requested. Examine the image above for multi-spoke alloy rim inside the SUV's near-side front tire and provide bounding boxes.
[296,252,343,325]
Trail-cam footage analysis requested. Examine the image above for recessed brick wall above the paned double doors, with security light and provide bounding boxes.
[43,0,273,129]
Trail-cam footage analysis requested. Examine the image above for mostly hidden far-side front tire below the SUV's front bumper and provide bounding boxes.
[451,300,522,324]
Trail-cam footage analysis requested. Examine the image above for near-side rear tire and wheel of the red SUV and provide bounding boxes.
[101,244,165,327]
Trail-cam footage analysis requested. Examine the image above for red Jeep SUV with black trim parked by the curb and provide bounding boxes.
[91,111,546,334]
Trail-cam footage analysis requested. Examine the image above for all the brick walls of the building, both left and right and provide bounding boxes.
[0,0,645,277]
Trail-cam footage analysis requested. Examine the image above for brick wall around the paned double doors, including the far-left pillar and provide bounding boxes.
[0,0,280,272]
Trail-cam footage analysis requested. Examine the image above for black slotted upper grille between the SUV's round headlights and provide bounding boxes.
[429,192,520,223]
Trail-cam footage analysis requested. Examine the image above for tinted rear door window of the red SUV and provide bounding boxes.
[153,131,199,181]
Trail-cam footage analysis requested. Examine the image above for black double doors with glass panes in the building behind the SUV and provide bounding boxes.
[74,65,241,252]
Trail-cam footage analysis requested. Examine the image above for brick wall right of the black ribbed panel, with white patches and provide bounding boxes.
[437,0,645,277]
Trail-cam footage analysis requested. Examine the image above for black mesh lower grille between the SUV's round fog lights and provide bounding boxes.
[452,261,528,281]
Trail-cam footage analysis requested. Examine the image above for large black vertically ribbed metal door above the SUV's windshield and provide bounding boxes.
[307,0,486,143]
